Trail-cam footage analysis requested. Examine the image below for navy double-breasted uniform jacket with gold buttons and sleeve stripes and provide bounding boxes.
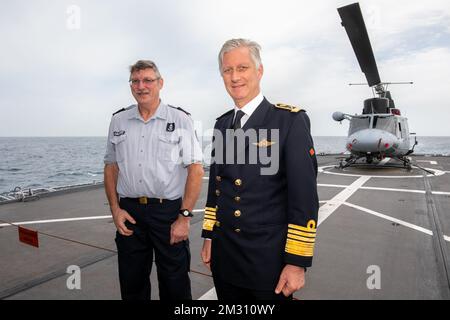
[202,99,319,290]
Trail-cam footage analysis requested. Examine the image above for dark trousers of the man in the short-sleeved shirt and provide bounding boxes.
[116,198,192,300]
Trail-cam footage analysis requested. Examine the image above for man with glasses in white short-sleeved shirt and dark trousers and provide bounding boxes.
[104,60,203,300]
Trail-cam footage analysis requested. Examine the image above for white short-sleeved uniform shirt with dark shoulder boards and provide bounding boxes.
[104,102,202,200]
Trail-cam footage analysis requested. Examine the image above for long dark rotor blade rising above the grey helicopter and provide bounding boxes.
[337,3,381,87]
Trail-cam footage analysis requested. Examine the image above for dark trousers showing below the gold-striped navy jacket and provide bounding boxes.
[213,275,292,301]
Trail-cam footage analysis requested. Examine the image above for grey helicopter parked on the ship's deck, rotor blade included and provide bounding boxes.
[333,3,418,170]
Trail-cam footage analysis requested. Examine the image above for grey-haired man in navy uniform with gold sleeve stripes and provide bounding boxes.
[201,39,319,299]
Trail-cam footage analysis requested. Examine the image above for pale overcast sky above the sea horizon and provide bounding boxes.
[0,0,450,136]
